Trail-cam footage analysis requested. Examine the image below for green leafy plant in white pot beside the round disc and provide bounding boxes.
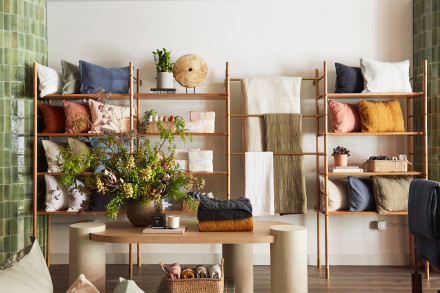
[153,48,174,89]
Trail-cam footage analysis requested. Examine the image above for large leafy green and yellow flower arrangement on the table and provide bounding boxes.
[59,90,205,219]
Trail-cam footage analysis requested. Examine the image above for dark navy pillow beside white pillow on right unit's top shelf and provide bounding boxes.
[335,63,364,93]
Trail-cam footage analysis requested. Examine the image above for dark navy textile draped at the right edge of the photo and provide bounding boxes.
[408,179,440,239]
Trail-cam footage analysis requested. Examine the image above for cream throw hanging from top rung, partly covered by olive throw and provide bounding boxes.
[241,76,301,152]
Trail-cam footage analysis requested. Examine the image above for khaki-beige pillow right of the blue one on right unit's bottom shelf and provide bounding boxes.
[373,176,413,213]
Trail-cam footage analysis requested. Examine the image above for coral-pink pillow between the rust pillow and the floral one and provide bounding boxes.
[64,101,92,133]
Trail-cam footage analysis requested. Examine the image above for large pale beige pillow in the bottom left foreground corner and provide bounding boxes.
[0,239,53,293]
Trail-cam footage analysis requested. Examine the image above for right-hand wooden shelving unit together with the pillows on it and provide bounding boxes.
[315,58,428,278]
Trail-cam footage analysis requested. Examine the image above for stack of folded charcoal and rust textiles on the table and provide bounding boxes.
[197,196,254,232]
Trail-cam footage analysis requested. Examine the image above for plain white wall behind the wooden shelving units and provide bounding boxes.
[47,0,412,265]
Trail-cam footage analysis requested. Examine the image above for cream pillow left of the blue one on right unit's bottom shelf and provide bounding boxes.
[319,176,348,211]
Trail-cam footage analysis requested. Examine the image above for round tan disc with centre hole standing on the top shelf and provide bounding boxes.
[174,54,208,87]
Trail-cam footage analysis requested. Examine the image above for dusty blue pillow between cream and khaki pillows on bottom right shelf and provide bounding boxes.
[348,176,376,212]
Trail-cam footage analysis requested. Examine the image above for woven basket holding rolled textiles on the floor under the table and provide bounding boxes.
[160,259,225,293]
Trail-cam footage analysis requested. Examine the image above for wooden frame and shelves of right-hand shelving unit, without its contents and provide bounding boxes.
[315,60,428,278]
